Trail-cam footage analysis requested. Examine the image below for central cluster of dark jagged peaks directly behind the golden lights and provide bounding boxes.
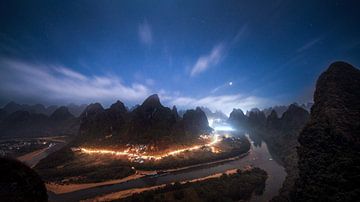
[76,94,212,149]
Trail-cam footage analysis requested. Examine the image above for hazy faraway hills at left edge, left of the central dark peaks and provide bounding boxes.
[0,102,87,138]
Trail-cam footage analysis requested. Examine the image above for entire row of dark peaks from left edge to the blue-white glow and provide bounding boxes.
[0,94,216,144]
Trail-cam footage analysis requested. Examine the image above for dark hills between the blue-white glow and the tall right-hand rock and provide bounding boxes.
[229,95,309,201]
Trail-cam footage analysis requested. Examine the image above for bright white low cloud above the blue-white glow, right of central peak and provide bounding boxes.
[167,94,272,115]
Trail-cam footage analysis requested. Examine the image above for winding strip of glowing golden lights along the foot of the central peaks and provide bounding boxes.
[73,135,221,160]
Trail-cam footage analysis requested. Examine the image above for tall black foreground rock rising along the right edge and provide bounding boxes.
[293,62,360,201]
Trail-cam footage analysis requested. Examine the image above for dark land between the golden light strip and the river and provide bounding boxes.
[35,138,250,186]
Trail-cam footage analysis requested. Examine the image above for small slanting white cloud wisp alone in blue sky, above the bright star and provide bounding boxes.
[190,43,225,76]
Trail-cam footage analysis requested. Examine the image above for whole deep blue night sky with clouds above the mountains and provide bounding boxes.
[0,0,360,113]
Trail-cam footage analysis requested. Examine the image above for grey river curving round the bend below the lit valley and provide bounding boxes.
[49,135,286,202]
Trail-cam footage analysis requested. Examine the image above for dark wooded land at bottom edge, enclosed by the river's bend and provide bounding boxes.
[113,168,267,201]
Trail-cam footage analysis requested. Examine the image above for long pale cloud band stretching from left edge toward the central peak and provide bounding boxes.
[0,59,150,102]
